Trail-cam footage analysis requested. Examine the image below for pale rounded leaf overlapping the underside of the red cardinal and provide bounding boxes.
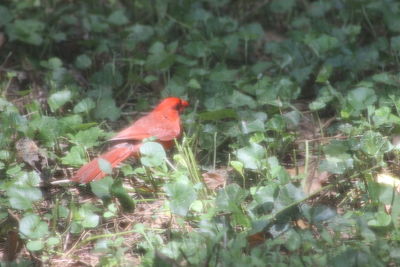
[140,142,167,167]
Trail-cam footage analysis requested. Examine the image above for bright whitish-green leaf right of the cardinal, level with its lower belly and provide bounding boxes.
[236,143,265,170]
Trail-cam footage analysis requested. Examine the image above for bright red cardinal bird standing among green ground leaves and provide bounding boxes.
[71,97,189,184]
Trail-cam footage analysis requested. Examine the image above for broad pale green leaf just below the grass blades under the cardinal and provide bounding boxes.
[164,181,197,216]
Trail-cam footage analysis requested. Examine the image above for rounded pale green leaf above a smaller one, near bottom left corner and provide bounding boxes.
[19,214,49,239]
